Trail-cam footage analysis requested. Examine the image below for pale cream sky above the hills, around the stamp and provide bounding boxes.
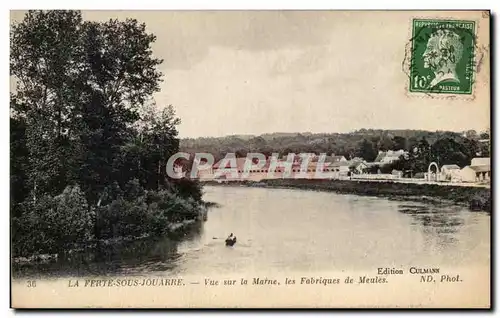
[10,11,490,137]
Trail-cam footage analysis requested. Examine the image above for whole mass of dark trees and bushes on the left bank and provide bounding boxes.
[10,10,201,253]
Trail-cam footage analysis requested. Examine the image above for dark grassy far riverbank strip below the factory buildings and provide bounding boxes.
[206,179,491,212]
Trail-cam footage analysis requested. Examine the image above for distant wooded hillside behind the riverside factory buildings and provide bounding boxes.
[180,129,489,162]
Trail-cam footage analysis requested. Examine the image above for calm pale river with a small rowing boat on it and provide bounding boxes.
[11,186,490,277]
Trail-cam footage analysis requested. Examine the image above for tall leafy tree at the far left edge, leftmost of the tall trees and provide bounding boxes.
[10,11,83,198]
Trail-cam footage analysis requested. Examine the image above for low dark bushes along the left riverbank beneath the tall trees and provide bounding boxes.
[12,180,201,255]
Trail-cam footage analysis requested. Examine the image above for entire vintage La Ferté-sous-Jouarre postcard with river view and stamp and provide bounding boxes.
[10,10,492,308]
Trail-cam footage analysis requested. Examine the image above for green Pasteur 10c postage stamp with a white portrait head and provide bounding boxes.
[409,19,476,94]
